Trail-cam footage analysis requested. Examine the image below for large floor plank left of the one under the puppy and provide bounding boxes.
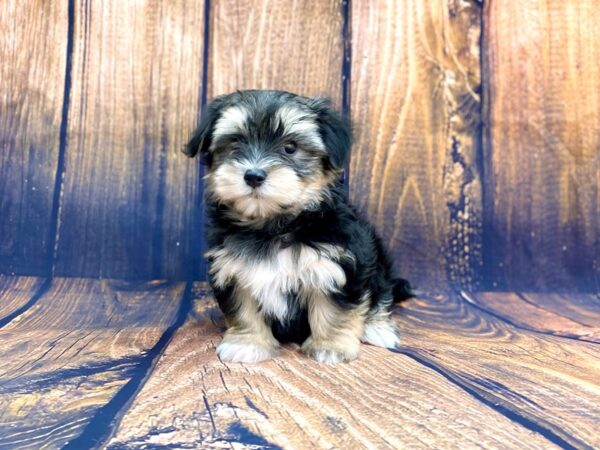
[0,279,184,449]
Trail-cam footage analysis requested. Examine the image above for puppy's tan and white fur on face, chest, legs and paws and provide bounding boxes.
[199,97,395,363]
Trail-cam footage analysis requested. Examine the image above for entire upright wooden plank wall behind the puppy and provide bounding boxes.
[0,0,600,290]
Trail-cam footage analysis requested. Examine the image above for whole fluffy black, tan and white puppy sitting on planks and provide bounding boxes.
[184,90,411,364]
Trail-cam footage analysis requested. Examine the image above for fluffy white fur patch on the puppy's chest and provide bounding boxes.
[207,243,353,320]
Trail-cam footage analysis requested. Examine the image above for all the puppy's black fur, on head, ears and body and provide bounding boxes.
[184,91,412,354]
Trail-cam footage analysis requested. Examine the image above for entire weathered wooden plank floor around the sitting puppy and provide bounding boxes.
[0,276,600,449]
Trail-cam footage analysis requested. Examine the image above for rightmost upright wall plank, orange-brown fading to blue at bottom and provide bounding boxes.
[484,0,600,292]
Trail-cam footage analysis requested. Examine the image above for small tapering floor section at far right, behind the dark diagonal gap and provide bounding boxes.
[463,292,600,343]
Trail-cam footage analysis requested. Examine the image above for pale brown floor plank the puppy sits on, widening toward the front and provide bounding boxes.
[107,298,564,449]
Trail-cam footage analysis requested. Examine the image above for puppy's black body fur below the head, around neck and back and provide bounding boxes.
[207,184,413,343]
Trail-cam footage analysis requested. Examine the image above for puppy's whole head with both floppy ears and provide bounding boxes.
[184,91,350,221]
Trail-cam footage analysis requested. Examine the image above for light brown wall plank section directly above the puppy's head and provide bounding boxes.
[208,0,343,104]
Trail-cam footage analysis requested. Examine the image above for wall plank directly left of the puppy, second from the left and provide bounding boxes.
[55,0,204,279]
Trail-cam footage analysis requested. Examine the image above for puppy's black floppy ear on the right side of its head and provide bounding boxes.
[311,98,352,169]
